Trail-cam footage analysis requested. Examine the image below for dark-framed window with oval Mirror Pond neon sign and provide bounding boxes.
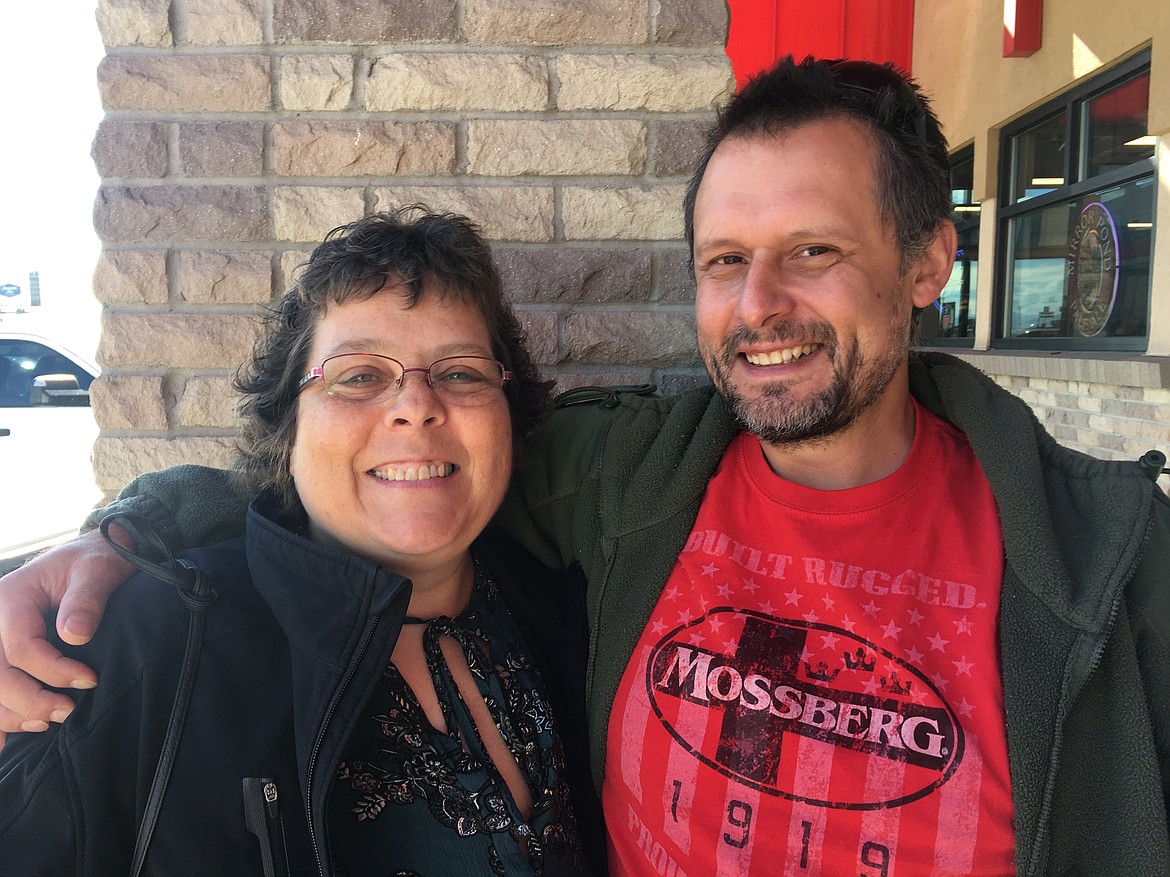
[995,53,1156,350]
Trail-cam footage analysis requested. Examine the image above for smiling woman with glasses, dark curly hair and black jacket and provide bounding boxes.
[0,208,597,876]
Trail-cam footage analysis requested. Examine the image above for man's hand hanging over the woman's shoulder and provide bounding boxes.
[0,526,135,746]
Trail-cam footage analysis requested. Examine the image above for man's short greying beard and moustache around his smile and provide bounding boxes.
[702,319,909,446]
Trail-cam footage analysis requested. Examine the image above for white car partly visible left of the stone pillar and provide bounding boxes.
[0,325,102,573]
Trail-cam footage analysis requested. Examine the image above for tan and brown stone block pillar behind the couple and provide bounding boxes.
[94,0,734,491]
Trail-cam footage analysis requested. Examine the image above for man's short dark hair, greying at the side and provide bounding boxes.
[683,55,951,270]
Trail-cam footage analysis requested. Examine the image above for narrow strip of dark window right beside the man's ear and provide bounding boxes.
[918,146,979,346]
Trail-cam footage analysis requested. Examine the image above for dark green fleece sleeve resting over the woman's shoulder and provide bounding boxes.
[82,465,255,552]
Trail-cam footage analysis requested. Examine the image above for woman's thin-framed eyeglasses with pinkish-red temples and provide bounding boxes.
[297,353,511,405]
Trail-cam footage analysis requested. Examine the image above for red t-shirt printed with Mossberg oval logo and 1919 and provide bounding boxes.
[603,406,1014,877]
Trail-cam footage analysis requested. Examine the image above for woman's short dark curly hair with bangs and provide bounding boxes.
[234,205,553,510]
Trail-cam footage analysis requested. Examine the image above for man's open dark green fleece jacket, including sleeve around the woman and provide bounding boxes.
[93,353,1170,877]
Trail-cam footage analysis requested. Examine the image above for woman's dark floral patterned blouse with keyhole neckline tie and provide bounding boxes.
[329,564,585,877]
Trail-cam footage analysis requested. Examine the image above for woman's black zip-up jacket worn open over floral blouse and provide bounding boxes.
[0,500,604,877]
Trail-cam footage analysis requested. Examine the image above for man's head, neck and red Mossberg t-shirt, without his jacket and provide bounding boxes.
[603,62,1014,875]
